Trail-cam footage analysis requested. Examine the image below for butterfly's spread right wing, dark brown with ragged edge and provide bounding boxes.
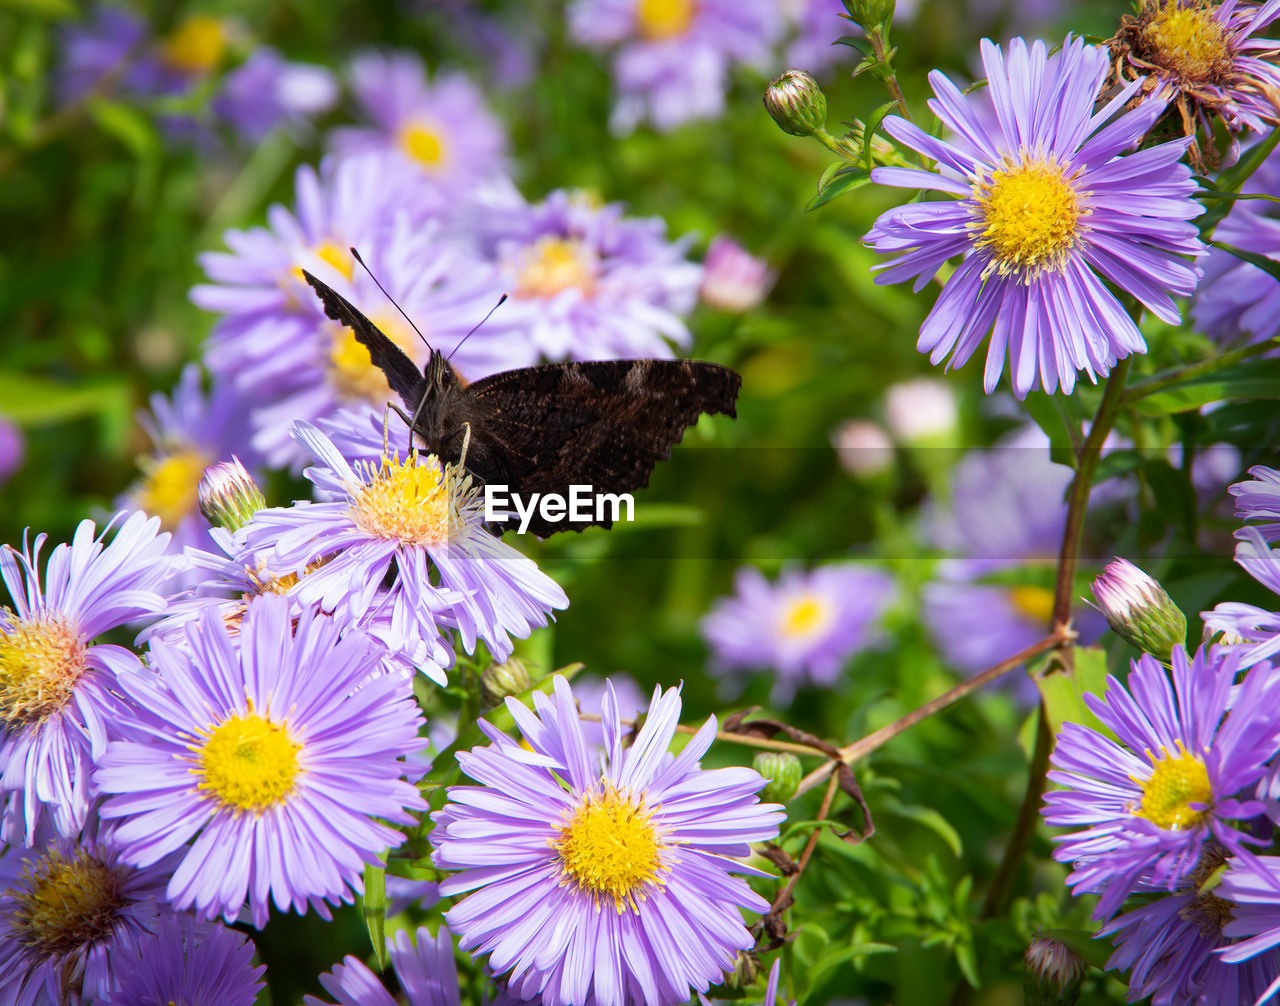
[467,360,742,538]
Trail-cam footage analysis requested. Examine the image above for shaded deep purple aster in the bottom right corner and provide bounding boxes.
[1098,845,1280,1006]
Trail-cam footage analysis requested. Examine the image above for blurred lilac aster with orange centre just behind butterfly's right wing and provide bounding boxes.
[475,189,703,369]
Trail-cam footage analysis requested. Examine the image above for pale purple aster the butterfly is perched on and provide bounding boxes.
[244,422,568,663]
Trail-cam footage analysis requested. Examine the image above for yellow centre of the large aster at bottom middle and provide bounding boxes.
[549,785,668,914]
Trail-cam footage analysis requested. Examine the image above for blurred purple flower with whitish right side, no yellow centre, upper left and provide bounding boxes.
[212,46,338,142]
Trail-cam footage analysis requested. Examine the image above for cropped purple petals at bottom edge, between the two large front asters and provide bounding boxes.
[302,925,461,1006]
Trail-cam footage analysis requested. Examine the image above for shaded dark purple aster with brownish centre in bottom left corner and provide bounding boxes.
[0,834,173,1006]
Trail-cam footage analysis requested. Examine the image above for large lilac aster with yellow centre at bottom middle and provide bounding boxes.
[431,676,783,1006]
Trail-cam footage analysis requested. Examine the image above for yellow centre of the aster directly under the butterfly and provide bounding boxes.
[351,453,471,545]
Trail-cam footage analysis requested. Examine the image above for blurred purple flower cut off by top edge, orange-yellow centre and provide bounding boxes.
[568,0,782,133]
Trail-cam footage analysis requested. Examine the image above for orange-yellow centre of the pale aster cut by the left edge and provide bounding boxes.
[0,614,86,726]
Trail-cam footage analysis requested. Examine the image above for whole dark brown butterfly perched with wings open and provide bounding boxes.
[303,266,742,538]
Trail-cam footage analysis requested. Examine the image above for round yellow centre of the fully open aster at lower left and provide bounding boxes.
[193,707,302,813]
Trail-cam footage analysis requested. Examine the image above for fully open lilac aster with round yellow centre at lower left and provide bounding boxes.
[95,596,426,928]
